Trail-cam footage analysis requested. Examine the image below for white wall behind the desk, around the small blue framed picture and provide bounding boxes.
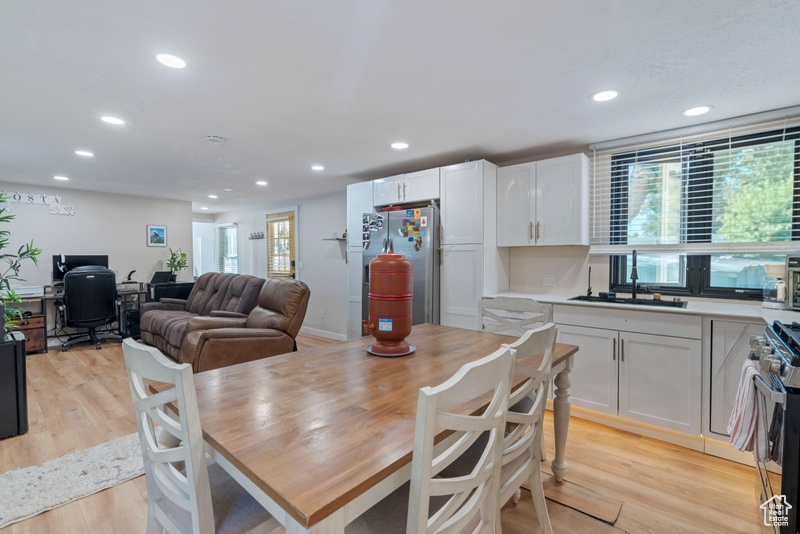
[0,182,192,285]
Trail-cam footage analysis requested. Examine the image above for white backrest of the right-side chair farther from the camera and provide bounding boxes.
[500,323,556,503]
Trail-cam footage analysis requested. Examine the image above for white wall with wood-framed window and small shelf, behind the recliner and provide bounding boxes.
[211,191,347,339]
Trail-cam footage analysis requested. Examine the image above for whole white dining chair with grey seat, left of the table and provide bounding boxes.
[122,339,279,534]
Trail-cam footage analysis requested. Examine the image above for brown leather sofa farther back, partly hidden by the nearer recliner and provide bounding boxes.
[139,273,265,361]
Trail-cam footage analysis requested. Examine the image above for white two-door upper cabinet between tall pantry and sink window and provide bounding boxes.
[497,154,589,247]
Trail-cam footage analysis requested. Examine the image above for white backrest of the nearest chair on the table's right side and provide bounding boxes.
[407,347,514,533]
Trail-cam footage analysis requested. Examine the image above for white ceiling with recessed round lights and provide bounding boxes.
[0,0,800,214]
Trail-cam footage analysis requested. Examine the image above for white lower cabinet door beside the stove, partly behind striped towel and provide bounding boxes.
[707,319,764,441]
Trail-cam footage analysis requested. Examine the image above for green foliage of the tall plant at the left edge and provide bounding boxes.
[0,194,42,339]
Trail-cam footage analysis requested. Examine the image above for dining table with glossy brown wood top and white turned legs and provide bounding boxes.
[189,324,578,534]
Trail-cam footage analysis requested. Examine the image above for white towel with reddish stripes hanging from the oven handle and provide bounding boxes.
[728,359,770,462]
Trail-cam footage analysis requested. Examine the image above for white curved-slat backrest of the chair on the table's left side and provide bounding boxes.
[122,339,215,534]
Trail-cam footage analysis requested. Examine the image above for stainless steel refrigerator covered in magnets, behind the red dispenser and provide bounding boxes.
[361,206,439,332]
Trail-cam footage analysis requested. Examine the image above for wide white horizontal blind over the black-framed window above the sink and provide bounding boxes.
[590,116,800,255]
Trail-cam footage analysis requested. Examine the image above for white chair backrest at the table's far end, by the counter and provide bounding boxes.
[479,297,553,336]
